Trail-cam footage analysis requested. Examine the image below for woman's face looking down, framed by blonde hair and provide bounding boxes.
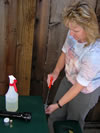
[69,22,86,43]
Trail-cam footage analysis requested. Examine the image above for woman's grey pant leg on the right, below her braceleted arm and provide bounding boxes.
[66,88,100,129]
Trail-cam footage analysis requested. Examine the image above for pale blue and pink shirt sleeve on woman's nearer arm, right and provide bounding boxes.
[76,52,100,86]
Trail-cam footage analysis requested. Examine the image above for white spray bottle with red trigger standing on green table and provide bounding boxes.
[5,75,18,112]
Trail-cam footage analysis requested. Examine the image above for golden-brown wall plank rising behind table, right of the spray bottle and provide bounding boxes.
[16,0,36,95]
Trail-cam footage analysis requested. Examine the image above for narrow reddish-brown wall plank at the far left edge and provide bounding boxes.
[0,0,6,95]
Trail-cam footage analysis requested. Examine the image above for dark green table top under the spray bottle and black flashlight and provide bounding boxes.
[0,96,48,133]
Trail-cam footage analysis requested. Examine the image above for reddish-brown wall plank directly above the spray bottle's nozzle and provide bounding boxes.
[5,0,17,78]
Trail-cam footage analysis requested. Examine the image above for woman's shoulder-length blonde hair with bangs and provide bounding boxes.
[63,2,100,46]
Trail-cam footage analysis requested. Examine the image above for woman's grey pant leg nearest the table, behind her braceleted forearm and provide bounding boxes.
[48,77,72,133]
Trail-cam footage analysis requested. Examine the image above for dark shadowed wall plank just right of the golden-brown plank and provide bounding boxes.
[31,0,50,95]
